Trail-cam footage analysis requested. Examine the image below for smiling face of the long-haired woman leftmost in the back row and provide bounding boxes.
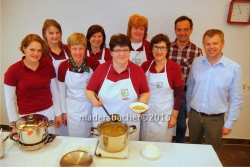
[45,26,62,45]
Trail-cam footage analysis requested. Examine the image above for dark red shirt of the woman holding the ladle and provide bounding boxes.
[87,60,149,95]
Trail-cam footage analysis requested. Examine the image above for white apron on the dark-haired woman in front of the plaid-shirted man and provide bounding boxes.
[140,61,174,142]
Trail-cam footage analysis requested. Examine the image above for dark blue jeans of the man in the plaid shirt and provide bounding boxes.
[176,91,187,143]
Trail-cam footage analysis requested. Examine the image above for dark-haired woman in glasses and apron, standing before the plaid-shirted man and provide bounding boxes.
[140,34,184,142]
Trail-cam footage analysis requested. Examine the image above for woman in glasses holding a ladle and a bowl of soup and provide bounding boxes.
[86,34,149,140]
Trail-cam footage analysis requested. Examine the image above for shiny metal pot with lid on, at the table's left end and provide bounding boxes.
[9,114,53,145]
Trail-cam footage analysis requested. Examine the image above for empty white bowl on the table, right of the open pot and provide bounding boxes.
[142,144,161,160]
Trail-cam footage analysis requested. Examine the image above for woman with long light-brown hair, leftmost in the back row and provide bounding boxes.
[42,19,69,135]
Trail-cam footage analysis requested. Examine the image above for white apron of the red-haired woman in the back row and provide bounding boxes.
[129,46,147,66]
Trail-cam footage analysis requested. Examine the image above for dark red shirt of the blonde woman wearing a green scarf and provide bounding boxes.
[58,56,100,82]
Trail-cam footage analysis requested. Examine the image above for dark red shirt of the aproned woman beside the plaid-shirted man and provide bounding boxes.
[141,59,184,111]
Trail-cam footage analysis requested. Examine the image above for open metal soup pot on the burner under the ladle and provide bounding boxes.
[90,121,136,152]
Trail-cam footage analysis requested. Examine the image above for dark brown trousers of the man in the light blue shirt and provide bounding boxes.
[188,109,224,153]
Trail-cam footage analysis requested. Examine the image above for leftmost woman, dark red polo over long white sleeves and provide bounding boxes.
[4,34,62,134]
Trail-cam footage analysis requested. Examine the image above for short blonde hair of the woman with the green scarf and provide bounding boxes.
[67,32,87,49]
